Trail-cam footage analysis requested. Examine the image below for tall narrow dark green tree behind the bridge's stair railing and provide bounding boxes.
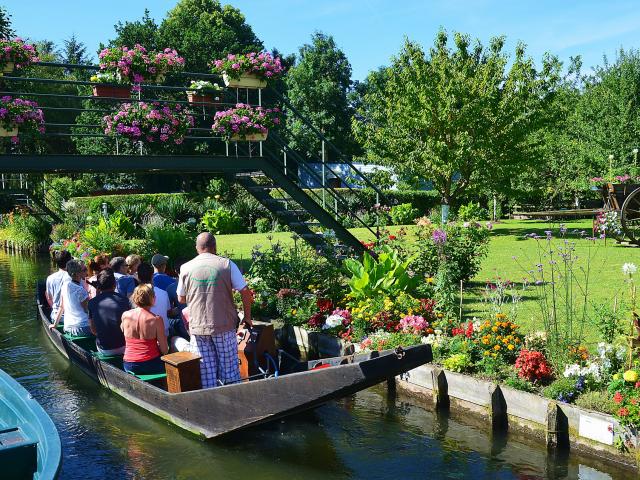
[285,32,357,157]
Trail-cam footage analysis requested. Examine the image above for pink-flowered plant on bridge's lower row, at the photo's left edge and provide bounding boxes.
[0,95,45,143]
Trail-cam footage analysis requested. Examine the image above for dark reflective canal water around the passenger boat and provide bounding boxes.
[0,252,633,480]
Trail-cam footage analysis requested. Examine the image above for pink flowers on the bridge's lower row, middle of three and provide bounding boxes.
[103,102,194,145]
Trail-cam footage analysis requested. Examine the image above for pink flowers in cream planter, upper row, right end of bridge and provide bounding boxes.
[212,52,284,88]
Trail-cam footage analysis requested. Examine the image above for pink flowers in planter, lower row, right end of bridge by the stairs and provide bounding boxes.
[211,103,280,142]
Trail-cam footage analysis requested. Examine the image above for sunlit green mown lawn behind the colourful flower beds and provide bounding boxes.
[217,220,640,343]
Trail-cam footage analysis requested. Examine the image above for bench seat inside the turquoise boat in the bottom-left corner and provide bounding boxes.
[0,427,38,478]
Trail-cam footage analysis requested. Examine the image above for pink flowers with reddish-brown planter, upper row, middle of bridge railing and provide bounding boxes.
[91,45,184,98]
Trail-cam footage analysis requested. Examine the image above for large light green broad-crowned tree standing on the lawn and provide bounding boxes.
[354,30,560,205]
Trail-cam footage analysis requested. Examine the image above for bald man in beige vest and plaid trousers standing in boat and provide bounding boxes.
[177,232,253,388]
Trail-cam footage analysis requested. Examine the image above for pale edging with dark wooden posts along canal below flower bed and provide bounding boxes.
[396,364,640,469]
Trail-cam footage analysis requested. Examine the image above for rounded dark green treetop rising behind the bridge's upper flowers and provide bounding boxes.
[158,0,263,72]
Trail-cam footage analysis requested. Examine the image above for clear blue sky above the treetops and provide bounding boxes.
[5,0,640,79]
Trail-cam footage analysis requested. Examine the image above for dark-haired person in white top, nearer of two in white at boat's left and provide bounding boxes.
[49,260,92,336]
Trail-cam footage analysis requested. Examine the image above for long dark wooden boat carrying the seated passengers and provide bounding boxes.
[38,282,431,439]
